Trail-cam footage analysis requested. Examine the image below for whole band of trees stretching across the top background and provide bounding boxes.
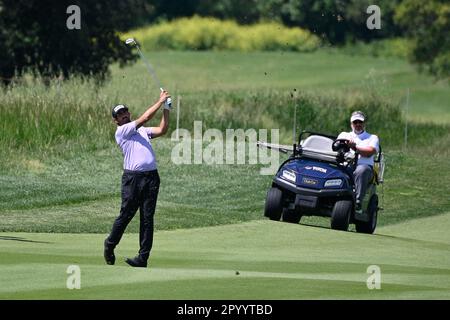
[0,0,450,81]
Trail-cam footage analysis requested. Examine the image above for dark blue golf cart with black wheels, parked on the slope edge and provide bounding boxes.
[258,131,384,234]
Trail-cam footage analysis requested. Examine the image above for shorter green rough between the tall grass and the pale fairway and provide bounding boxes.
[0,138,450,233]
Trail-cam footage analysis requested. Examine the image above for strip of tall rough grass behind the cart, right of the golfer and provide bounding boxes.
[173,90,440,146]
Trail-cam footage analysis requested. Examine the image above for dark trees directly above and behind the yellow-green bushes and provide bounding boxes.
[125,0,402,45]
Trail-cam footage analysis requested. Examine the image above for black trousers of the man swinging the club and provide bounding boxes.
[106,170,160,261]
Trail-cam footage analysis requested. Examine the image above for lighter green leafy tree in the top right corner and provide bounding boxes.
[395,0,450,78]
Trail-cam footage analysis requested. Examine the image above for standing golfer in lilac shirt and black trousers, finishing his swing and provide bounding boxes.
[104,91,170,268]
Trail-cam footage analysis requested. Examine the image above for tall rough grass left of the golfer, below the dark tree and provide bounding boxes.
[0,79,112,151]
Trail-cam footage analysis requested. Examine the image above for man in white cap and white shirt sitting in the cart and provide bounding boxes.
[338,111,379,213]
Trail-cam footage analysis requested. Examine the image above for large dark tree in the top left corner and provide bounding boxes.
[0,0,150,80]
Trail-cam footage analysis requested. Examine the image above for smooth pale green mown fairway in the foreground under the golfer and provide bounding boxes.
[0,213,450,300]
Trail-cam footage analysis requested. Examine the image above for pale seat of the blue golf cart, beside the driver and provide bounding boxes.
[301,135,337,162]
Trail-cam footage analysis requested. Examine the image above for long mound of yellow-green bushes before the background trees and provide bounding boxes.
[123,16,320,52]
